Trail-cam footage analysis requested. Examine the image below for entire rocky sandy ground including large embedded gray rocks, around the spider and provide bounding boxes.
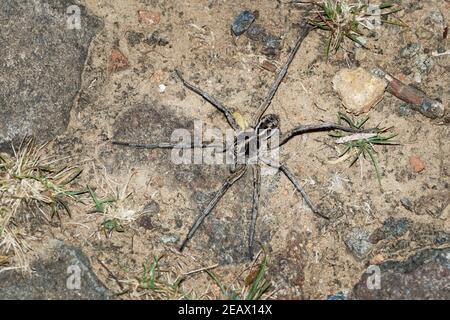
[0,0,450,299]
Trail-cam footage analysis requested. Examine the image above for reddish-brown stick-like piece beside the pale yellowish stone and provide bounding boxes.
[374,69,444,119]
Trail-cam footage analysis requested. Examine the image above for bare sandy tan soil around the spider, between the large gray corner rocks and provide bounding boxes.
[7,0,450,299]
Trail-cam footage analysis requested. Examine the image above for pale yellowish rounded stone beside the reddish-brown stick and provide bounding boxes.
[333,68,387,115]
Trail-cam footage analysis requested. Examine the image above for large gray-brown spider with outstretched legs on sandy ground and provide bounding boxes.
[113,24,376,258]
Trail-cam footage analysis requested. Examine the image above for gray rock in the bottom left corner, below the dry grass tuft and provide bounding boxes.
[0,240,113,300]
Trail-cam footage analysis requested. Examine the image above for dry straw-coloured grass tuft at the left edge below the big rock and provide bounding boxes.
[0,138,82,271]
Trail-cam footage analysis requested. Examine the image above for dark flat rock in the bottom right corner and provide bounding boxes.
[353,248,450,300]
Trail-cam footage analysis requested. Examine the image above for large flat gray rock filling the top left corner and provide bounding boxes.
[0,0,102,148]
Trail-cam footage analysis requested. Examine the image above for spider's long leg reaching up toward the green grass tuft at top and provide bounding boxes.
[253,24,312,126]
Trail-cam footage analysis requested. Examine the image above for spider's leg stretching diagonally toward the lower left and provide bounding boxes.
[180,165,247,251]
